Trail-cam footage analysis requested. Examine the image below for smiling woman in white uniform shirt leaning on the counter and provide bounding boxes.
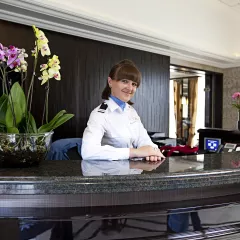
[81,60,165,161]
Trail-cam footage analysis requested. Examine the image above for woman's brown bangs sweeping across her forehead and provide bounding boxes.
[114,65,141,87]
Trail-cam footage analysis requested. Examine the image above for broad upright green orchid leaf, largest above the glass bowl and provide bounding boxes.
[5,82,27,128]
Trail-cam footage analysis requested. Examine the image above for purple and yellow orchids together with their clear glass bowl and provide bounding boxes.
[0,26,74,166]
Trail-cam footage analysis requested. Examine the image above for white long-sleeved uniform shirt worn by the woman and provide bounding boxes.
[81,98,157,160]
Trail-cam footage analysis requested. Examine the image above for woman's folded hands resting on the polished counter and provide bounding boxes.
[130,146,165,161]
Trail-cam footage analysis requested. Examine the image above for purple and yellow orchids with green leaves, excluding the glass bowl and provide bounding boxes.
[0,26,74,133]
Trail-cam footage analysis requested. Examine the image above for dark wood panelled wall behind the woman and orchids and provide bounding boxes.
[0,20,170,138]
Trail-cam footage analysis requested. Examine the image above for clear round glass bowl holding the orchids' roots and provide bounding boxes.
[0,132,53,167]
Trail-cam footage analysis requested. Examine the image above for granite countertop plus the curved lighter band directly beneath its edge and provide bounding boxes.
[0,152,240,208]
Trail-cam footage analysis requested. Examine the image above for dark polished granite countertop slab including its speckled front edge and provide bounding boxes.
[0,152,240,194]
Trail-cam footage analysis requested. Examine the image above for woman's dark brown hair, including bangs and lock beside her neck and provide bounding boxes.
[102,59,142,105]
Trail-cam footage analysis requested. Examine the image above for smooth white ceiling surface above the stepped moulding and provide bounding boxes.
[33,0,240,57]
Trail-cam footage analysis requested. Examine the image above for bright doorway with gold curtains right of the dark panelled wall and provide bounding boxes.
[169,65,223,147]
